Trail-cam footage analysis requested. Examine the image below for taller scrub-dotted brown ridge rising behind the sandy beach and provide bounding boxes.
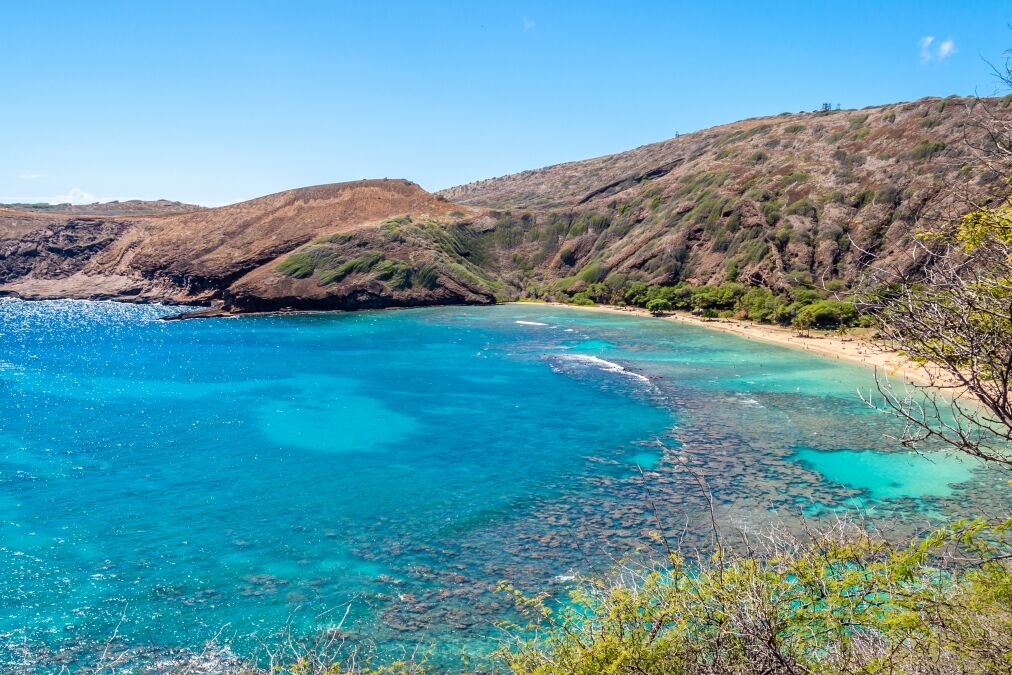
[441,97,1009,291]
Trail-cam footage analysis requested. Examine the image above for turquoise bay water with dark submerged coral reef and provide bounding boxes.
[0,301,1009,669]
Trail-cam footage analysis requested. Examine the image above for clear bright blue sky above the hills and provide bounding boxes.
[0,0,1012,205]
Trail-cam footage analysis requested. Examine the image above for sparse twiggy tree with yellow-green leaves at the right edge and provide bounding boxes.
[861,61,1012,468]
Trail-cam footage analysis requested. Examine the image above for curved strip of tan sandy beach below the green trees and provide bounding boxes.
[518,302,958,390]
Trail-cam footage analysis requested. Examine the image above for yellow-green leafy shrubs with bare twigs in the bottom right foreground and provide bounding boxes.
[499,520,1012,675]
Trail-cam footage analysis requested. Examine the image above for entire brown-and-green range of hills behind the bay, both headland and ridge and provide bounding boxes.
[0,97,1009,312]
